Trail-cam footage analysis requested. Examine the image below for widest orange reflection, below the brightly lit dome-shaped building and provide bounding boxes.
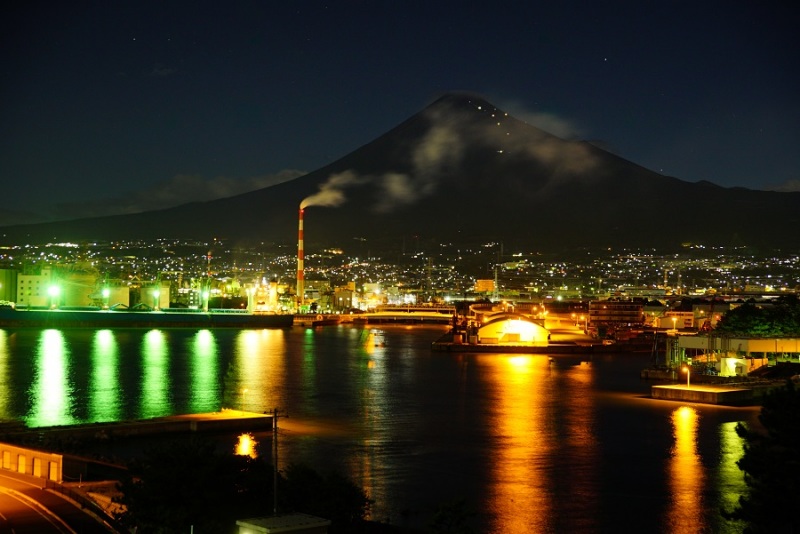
[477,355,553,532]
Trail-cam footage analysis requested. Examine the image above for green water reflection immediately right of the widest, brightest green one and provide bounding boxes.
[89,329,122,422]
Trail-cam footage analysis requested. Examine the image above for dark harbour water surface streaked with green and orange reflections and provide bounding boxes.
[0,326,758,533]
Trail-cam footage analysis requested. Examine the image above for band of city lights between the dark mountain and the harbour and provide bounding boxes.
[0,240,800,313]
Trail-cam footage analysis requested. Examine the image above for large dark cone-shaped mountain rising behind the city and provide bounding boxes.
[0,93,800,250]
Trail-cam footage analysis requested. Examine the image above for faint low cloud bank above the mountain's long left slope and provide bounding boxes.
[52,170,306,219]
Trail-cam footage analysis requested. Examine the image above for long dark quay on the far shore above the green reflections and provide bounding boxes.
[0,307,294,328]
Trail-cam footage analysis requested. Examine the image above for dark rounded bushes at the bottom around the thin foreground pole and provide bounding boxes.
[119,439,370,534]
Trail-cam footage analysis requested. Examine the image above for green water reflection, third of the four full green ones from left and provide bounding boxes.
[139,330,172,419]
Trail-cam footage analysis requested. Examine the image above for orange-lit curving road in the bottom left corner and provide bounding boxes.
[0,471,113,534]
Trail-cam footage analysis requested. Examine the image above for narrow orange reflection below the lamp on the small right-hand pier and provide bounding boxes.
[667,406,705,534]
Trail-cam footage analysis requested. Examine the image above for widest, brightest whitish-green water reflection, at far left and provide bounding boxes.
[25,329,74,427]
